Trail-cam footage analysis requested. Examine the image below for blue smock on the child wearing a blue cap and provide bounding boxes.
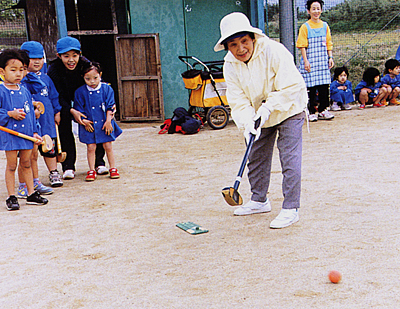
[22,73,61,138]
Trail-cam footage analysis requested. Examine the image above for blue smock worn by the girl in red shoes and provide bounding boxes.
[74,83,122,144]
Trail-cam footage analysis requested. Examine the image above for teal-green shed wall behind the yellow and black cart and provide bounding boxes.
[129,0,249,118]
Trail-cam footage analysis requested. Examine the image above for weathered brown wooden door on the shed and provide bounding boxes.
[115,34,164,121]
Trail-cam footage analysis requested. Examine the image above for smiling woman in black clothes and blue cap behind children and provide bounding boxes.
[47,36,108,179]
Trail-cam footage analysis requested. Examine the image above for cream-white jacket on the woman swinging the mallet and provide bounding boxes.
[224,37,308,129]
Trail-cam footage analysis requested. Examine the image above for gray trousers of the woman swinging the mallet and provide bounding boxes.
[248,112,305,209]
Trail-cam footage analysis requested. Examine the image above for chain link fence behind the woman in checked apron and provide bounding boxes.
[265,0,400,86]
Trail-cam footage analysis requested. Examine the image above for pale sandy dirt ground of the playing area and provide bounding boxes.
[0,106,400,309]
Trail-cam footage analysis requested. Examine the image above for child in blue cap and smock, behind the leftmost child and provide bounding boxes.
[18,41,63,198]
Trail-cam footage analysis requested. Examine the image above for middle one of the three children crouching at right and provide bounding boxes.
[354,67,389,109]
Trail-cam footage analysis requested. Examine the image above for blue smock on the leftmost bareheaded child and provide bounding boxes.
[0,83,38,151]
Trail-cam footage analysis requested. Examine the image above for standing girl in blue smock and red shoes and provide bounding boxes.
[74,62,122,181]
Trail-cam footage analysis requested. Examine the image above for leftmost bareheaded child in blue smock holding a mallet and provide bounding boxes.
[0,49,48,210]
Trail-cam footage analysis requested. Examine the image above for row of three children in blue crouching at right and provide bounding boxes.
[330,59,400,111]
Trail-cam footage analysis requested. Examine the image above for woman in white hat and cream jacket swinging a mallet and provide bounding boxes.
[214,13,307,228]
